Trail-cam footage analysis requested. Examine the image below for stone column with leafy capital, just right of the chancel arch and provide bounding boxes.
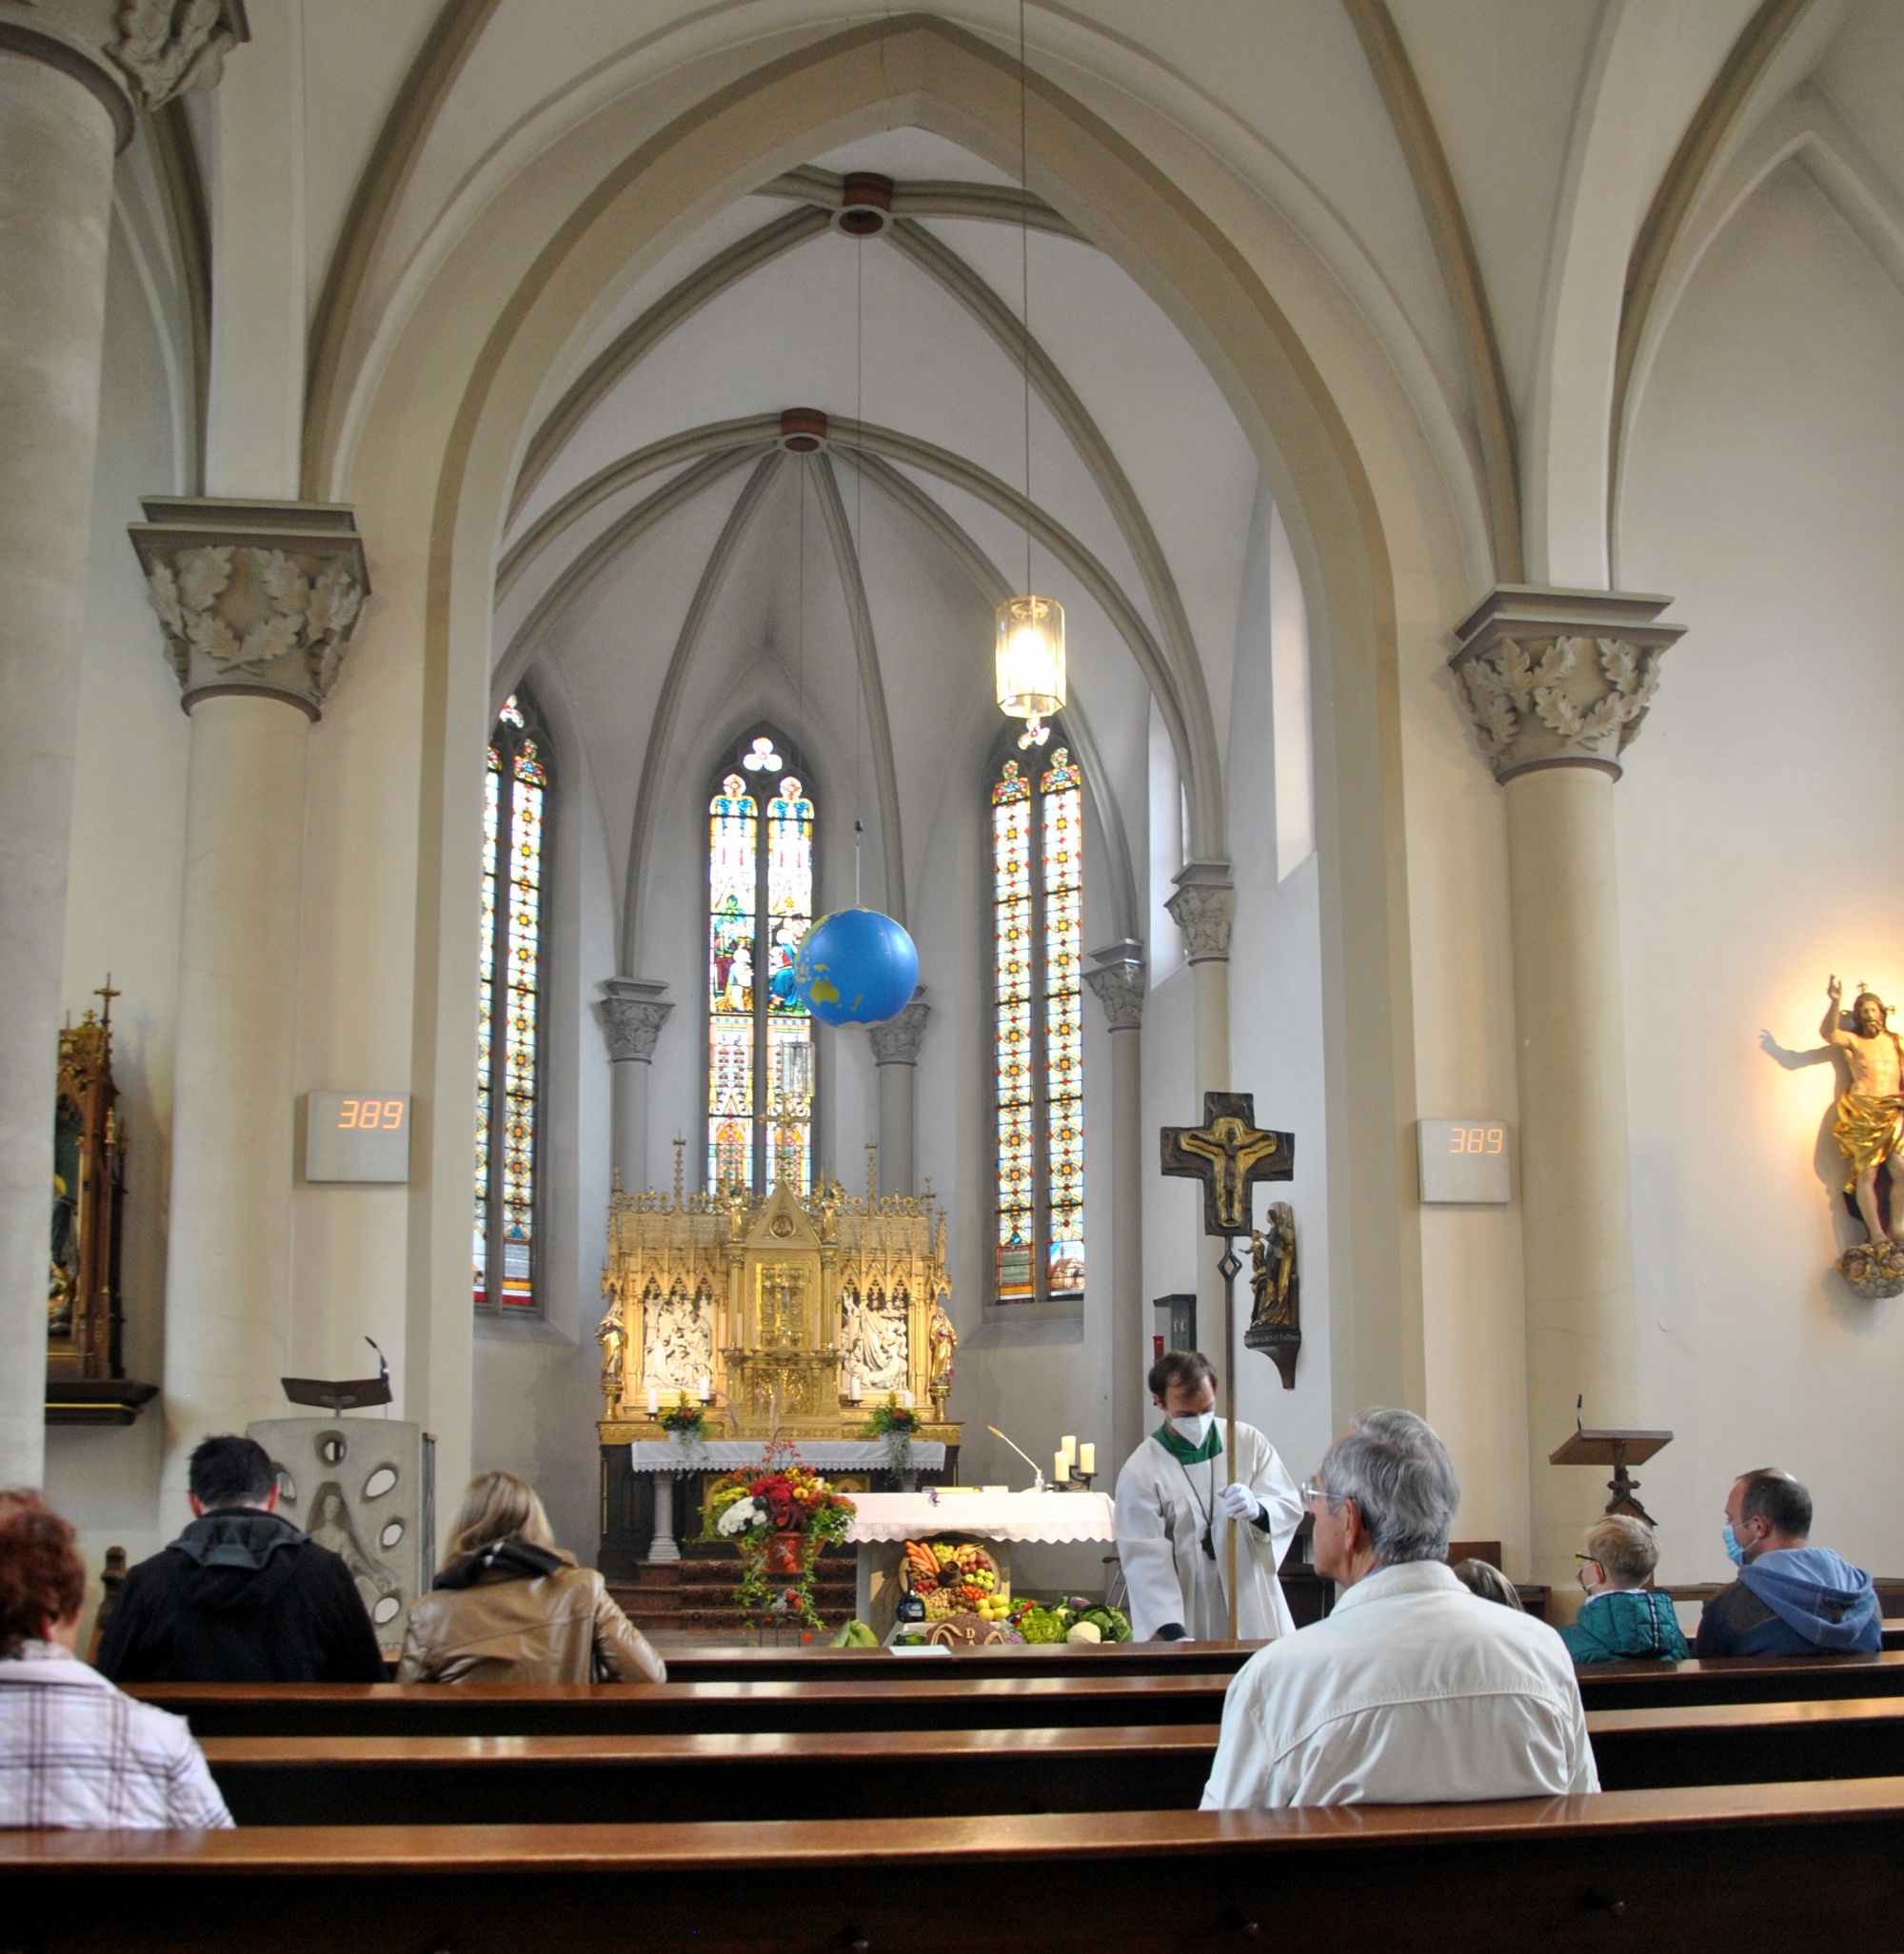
[1451,586,1683,1587]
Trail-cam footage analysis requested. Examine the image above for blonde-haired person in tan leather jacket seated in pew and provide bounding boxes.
[397,1471,668,1683]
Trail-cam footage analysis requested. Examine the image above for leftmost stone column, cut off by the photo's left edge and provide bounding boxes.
[0,0,245,1485]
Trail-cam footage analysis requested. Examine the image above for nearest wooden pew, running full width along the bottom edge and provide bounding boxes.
[0,1778,1904,1954]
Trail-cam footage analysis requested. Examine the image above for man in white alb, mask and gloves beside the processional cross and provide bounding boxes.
[1116,1351,1302,1642]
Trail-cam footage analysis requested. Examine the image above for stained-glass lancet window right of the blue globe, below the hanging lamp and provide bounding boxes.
[991,746,1085,1303]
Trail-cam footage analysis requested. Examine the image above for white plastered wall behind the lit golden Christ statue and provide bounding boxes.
[1616,164,1904,1581]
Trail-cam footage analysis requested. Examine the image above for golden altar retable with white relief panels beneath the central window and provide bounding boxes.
[596,1180,960,1446]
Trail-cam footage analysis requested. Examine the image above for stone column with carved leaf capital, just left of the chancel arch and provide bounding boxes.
[131,496,369,1487]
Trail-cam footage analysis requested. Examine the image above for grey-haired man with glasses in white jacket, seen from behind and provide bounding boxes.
[1202,1411,1599,1811]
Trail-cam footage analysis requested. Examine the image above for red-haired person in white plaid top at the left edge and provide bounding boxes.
[0,1492,230,1829]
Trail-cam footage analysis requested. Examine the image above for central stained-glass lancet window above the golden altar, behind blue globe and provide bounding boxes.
[707,733,813,1194]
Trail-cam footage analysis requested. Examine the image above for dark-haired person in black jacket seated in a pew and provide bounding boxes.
[96,1436,386,1683]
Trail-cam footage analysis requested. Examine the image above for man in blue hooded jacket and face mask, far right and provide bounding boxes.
[1693,1466,1882,1661]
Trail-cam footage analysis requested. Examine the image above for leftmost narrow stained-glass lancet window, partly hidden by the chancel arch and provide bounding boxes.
[473,694,549,1310]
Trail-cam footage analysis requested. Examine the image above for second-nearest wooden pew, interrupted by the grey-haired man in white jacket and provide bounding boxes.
[206,1698,1904,1826]
